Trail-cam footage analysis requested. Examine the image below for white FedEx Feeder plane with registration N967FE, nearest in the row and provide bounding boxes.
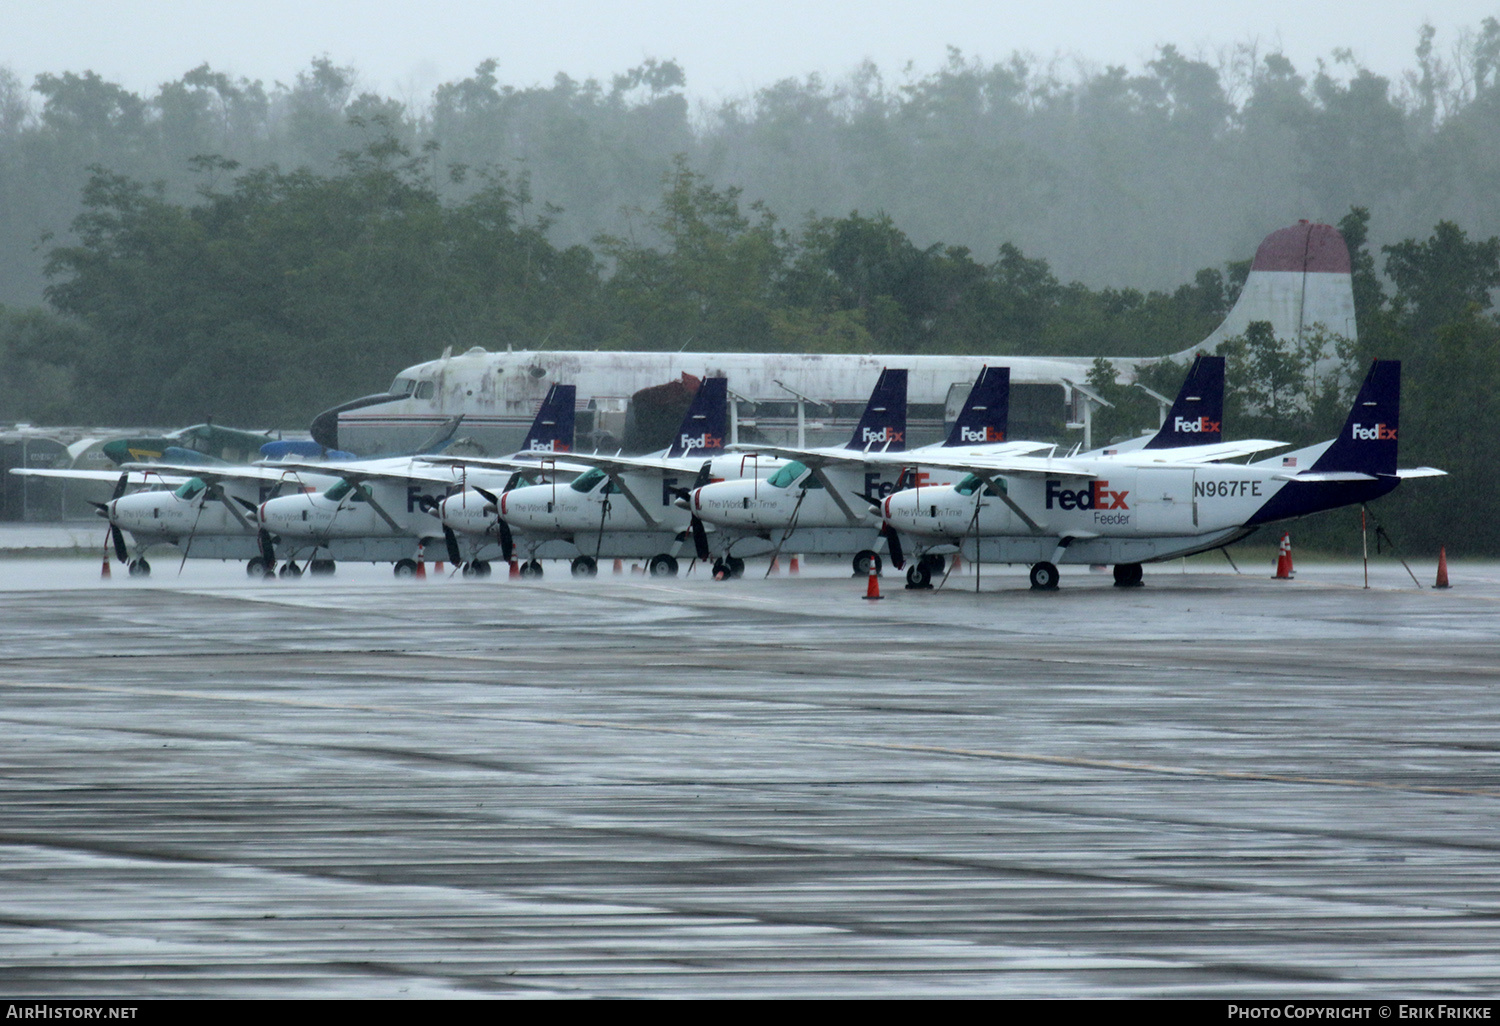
[881,360,1443,588]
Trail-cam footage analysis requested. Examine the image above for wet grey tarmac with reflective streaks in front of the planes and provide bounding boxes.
[0,558,1500,999]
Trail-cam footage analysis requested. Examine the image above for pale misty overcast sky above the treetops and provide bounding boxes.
[0,0,1500,105]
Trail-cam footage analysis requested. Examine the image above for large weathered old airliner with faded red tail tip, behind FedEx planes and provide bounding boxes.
[311,222,1355,455]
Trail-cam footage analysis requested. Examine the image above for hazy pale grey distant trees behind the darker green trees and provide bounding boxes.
[0,18,1500,305]
